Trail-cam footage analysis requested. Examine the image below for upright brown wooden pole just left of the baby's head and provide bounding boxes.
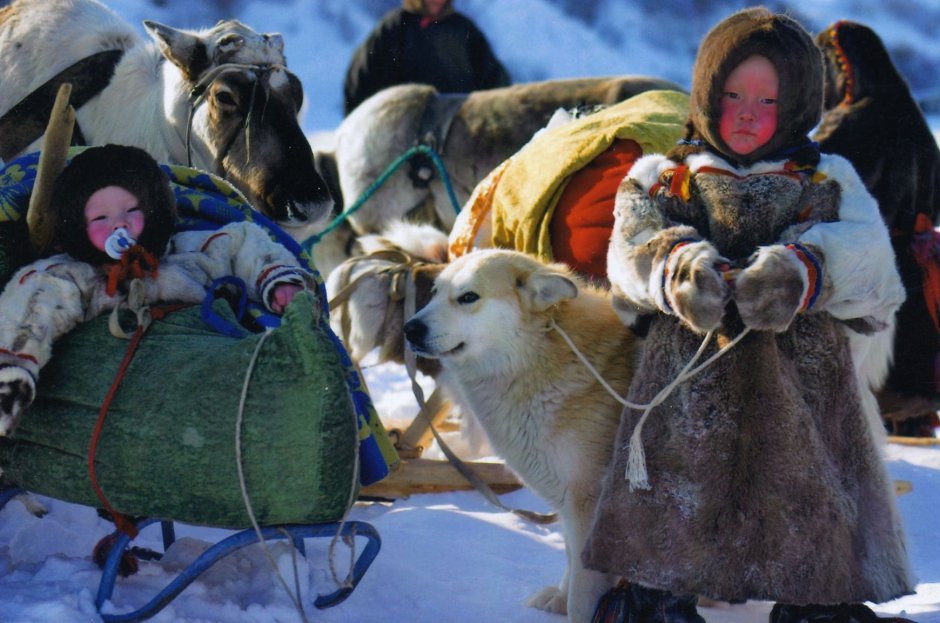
[26,82,75,257]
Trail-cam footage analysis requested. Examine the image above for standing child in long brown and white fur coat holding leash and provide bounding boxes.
[583,8,914,623]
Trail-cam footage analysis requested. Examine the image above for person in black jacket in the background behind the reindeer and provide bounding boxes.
[343,0,510,115]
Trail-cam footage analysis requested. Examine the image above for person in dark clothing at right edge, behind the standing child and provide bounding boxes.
[813,21,940,436]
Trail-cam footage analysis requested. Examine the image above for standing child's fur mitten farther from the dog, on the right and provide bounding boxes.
[734,245,815,333]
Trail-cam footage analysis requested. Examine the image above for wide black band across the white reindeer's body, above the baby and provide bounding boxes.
[0,50,124,161]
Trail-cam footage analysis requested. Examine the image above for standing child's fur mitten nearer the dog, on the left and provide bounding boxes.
[663,240,731,333]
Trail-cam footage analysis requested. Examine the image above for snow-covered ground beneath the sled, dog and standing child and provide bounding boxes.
[0,348,940,623]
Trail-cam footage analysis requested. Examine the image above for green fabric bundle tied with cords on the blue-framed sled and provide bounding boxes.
[0,293,358,528]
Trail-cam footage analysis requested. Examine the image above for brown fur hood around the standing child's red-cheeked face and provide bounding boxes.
[687,7,823,164]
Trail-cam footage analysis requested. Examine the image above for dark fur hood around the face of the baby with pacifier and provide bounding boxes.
[49,145,176,265]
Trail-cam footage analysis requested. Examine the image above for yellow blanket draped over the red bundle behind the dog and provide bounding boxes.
[491,91,689,261]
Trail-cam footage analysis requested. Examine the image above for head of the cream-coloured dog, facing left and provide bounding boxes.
[404,249,578,369]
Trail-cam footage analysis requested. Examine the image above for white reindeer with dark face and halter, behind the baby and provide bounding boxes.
[0,0,333,246]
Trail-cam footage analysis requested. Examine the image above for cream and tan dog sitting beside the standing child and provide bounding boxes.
[404,250,636,622]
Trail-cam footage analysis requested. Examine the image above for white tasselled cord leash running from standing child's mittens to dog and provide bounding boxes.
[549,320,751,491]
